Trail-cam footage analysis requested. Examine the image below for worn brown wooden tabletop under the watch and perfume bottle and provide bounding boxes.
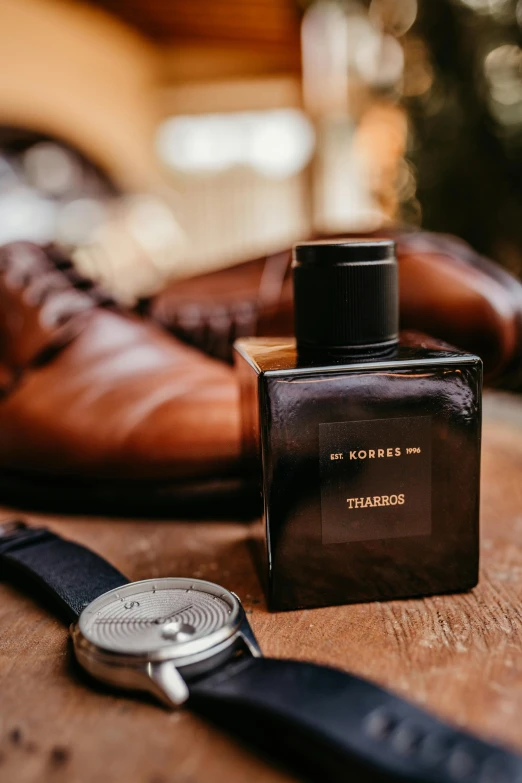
[0,395,522,783]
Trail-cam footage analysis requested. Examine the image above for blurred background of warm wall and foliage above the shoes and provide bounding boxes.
[0,0,522,304]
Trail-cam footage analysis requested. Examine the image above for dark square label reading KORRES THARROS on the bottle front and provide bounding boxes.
[319,416,431,544]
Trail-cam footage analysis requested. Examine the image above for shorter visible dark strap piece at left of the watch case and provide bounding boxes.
[0,522,129,622]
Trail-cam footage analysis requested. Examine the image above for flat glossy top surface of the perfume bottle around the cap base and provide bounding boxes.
[235,332,482,376]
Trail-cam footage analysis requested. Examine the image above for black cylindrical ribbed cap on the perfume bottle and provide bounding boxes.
[292,239,399,356]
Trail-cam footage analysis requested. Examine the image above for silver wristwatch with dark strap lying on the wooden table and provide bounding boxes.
[0,521,522,783]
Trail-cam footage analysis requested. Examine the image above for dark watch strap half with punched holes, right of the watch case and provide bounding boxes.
[190,658,522,783]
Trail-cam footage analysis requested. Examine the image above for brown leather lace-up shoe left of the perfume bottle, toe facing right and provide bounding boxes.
[0,242,240,514]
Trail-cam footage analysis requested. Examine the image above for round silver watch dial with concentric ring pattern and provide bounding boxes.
[79,579,240,658]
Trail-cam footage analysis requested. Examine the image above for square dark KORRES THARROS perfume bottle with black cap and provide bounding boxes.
[235,239,482,610]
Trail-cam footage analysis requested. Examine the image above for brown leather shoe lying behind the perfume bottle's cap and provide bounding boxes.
[144,230,522,388]
